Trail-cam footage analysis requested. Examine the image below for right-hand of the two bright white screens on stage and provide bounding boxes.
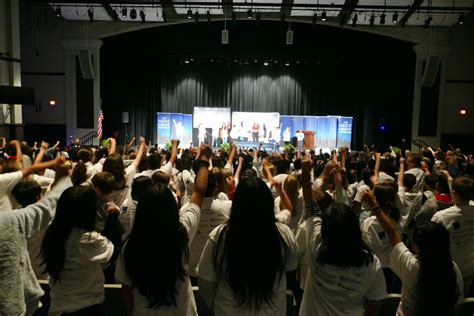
[230,112,281,143]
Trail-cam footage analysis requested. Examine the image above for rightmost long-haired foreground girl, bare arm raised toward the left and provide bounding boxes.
[369,188,463,316]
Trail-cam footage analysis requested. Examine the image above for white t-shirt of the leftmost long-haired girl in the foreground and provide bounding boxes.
[49,228,114,315]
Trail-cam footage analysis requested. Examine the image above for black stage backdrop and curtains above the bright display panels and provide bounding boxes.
[101,21,415,149]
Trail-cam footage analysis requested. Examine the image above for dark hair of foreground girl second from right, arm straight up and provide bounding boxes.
[318,202,374,267]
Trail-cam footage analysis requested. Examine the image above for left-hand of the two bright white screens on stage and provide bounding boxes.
[193,107,230,147]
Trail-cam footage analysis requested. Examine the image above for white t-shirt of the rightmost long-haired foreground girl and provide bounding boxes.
[390,242,464,316]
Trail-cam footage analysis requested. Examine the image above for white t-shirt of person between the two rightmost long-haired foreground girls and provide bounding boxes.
[361,216,401,268]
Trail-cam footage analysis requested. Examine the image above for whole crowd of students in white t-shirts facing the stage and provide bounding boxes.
[0,138,474,316]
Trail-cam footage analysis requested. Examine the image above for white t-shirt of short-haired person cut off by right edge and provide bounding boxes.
[431,205,474,277]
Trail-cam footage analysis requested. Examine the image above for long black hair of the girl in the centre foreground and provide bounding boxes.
[213,177,288,310]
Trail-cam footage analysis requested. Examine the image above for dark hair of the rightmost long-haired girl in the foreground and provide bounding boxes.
[413,221,459,316]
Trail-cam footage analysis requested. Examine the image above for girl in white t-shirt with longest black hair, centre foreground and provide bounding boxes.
[196,176,297,315]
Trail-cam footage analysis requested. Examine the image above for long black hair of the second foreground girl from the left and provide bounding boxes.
[124,183,189,308]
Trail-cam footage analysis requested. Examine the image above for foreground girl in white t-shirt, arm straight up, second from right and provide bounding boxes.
[300,157,386,316]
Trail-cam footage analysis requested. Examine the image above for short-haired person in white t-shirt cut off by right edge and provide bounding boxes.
[431,177,474,294]
